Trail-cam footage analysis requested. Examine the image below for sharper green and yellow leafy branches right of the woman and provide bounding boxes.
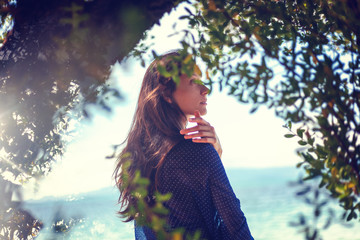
[133,0,360,220]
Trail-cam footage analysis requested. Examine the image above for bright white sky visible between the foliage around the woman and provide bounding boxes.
[21,2,300,199]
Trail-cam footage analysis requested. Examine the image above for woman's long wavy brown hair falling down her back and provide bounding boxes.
[114,52,186,222]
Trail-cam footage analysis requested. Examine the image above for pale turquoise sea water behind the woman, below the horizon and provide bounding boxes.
[25,168,360,240]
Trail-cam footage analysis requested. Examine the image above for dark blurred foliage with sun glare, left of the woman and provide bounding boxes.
[0,0,175,239]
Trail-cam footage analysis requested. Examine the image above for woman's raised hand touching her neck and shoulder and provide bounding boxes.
[180,111,222,158]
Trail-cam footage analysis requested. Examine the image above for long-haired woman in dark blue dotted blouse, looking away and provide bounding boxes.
[115,52,253,240]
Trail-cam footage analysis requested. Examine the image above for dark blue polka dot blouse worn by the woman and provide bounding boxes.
[135,140,253,240]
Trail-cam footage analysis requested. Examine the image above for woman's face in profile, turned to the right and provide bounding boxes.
[173,74,209,117]
